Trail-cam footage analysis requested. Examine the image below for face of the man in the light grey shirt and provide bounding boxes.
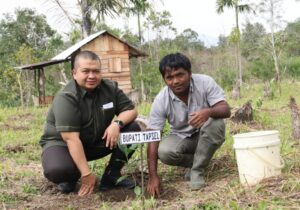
[164,68,191,95]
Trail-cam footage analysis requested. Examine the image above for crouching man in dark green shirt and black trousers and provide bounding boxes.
[40,51,140,196]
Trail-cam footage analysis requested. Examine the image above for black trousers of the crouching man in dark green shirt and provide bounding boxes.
[42,122,141,184]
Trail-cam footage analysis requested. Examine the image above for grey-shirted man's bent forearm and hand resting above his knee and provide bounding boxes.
[188,101,231,128]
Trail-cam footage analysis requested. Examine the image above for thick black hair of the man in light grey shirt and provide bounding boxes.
[159,52,191,77]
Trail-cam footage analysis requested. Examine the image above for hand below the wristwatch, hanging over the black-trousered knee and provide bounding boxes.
[102,122,120,149]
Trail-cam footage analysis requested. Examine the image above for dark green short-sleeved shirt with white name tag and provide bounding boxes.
[40,79,134,149]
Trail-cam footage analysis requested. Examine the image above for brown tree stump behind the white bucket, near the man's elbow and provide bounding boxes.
[231,101,253,123]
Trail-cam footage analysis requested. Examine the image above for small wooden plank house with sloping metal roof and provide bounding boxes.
[16,31,146,104]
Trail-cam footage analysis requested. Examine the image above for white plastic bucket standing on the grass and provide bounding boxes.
[233,130,283,186]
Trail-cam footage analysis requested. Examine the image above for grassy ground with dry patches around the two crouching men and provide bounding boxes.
[0,81,300,210]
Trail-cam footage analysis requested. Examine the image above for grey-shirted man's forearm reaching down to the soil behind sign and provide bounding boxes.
[147,142,160,196]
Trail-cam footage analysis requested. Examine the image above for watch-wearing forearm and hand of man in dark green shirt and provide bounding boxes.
[102,109,137,149]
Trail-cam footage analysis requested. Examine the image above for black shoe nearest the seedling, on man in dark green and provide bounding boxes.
[99,173,136,191]
